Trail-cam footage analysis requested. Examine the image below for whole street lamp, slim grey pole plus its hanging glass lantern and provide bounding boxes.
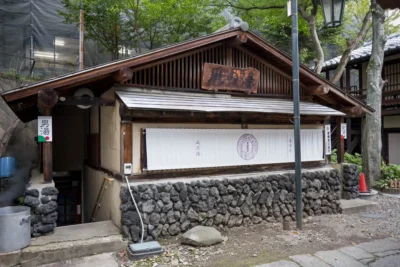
[288,0,344,230]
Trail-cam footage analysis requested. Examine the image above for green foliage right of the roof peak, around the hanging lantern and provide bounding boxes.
[214,0,400,66]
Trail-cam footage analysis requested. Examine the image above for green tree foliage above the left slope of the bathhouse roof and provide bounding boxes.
[59,0,226,59]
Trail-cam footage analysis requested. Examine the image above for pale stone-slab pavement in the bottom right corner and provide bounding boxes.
[255,238,400,267]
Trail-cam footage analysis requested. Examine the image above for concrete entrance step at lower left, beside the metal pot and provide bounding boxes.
[0,221,128,267]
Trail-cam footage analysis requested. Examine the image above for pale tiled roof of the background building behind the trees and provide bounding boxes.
[323,34,400,70]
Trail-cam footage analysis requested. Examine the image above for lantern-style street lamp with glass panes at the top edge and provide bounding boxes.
[321,0,344,28]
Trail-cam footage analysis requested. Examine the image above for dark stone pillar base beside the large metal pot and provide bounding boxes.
[24,178,58,237]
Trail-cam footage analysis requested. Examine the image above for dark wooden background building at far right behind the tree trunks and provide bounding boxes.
[323,34,400,164]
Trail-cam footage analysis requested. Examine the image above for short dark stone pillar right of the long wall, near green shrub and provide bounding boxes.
[342,164,360,199]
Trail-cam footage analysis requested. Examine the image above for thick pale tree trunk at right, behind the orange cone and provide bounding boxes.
[362,0,386,187]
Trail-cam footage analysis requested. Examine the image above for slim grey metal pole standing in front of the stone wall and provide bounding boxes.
[291,0,303,230]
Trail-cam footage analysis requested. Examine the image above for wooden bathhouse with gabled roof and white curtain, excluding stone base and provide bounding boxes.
[2,28,373,228]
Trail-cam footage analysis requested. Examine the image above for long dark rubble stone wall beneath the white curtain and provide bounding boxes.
[120,169,342,242]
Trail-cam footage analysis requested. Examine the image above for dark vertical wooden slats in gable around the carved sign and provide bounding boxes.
[127,43,303,96]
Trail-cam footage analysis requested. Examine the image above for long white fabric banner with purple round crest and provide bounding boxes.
[146,128,323,170]
